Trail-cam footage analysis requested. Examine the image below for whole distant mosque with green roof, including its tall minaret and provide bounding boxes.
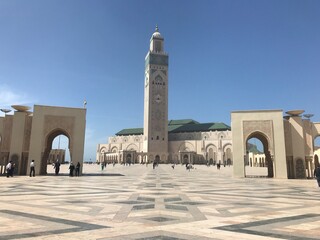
[97,28,232,164]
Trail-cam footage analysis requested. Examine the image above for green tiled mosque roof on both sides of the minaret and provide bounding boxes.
[116,119,231,136]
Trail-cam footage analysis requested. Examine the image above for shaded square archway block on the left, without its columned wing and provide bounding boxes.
[27,105,86,174]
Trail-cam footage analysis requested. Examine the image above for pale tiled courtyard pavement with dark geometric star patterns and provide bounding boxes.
[0,165,320,240]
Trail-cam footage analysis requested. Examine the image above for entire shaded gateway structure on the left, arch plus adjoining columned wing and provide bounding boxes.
[0,105,86,175]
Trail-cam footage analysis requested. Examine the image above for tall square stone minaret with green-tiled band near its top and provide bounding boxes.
[143,26,168,162]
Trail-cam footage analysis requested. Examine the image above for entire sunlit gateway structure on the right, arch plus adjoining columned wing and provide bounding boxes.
[231,110,320,179]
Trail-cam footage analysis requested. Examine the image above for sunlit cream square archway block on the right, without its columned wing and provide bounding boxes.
[231,110,288,178]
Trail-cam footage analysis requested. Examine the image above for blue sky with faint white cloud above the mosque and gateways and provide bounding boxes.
[0,0,320,160]
